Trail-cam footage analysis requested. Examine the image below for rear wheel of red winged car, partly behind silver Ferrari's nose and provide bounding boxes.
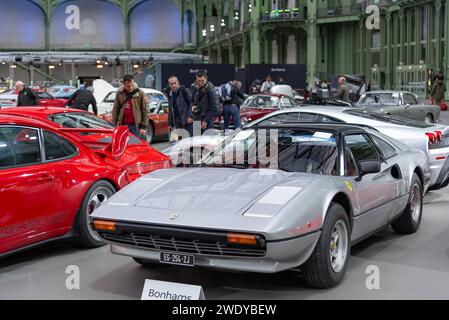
[74,180,116,248]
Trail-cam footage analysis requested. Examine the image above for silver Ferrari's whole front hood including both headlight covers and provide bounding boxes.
[100,168,316,215]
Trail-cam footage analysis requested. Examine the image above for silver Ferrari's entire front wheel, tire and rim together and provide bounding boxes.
[302,203,351,289]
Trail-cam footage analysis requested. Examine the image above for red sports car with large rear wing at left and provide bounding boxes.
[0,107,172,256]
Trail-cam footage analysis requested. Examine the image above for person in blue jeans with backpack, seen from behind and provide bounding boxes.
[220,80,245,131]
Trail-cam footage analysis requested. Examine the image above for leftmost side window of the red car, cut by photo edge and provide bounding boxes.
[0,127,41,169]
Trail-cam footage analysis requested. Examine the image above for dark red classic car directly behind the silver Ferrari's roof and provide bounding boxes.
[240,93,299,125]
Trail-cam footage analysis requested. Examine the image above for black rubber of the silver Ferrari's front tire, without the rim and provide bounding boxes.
[301,203,351,289]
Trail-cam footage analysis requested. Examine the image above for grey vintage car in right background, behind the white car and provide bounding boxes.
[357,91,441,123]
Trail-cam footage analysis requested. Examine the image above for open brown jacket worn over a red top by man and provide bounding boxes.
[112,83,150,129]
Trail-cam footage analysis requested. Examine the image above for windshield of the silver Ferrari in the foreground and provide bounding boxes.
[199,129,338,176]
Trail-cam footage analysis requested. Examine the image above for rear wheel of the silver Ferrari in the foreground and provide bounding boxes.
[391,173,423,234]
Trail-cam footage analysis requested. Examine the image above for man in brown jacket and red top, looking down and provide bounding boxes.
[112,75,150,136]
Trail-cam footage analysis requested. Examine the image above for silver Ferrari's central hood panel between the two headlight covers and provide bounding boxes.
[134,168,289,215]
